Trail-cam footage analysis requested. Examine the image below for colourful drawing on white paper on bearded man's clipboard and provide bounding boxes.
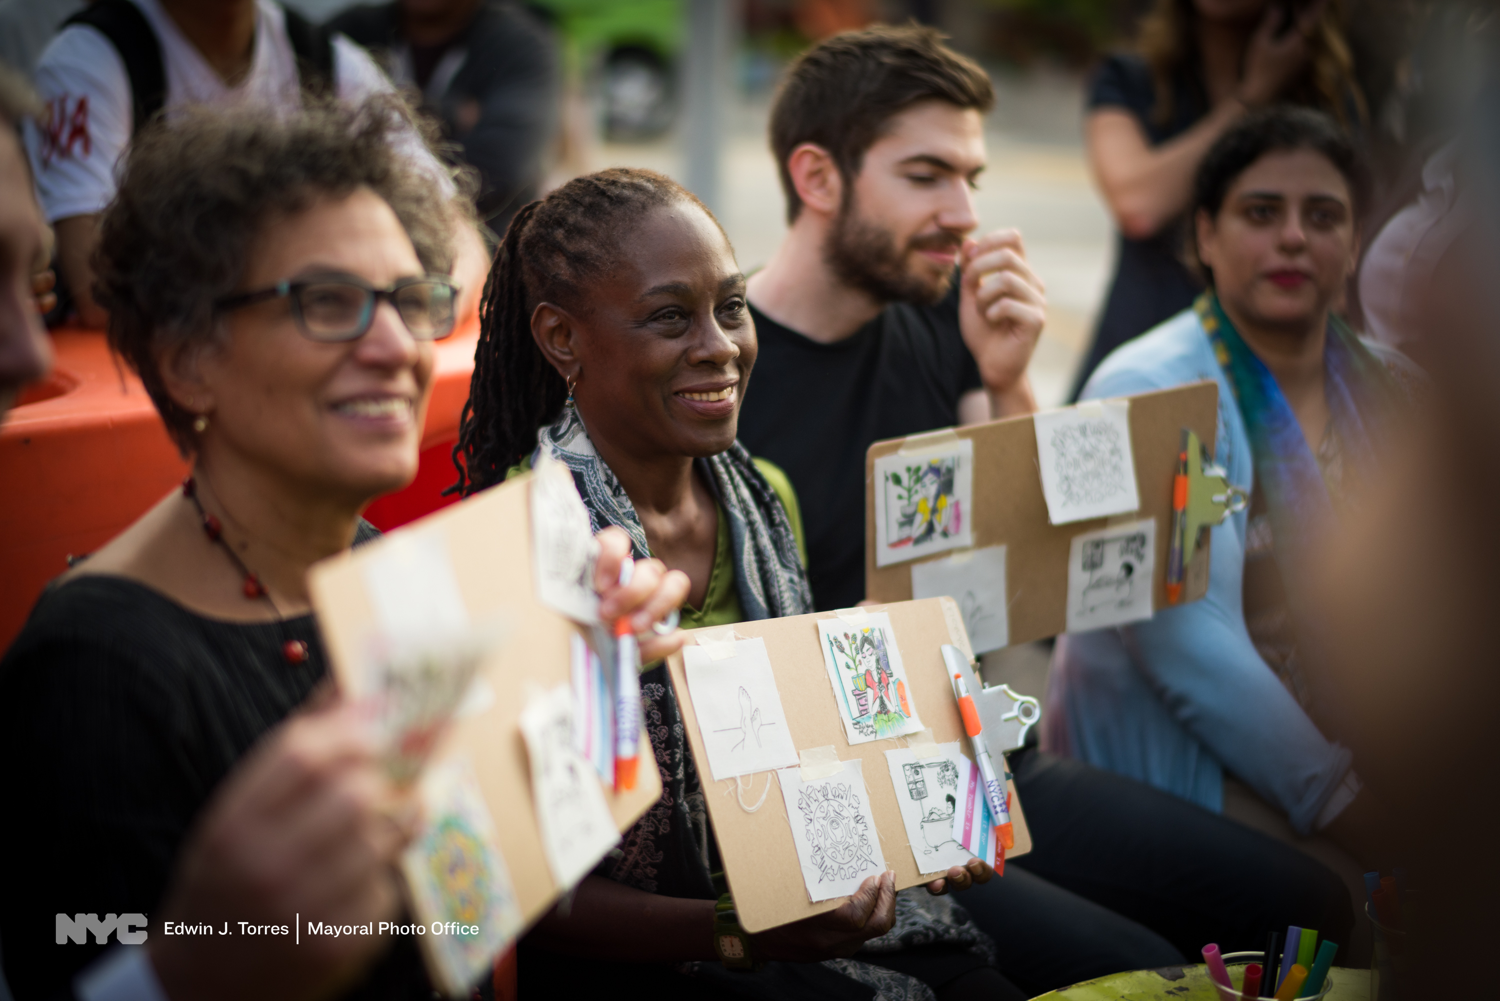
[875,438,974,566]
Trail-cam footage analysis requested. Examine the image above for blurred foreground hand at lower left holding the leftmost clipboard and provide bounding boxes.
[147,704,420,1001]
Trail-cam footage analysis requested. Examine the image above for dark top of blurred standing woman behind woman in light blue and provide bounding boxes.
[1073,53,1209,396]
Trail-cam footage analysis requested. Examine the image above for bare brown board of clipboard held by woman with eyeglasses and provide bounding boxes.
[309,476,662,942]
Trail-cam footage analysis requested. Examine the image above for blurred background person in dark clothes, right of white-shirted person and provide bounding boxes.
[329,0,560,234]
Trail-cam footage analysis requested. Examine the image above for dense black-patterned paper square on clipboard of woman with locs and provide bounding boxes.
[776,758,885,903]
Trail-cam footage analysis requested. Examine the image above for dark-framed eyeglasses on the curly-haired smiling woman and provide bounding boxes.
[215,275,459,342]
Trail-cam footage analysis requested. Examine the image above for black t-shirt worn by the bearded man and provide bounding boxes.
[740,287,983,611]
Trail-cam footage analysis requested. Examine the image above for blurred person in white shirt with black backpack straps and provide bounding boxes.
[27,0,488,327]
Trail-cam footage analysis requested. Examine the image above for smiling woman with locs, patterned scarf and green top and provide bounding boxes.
[456,168,1023,1001]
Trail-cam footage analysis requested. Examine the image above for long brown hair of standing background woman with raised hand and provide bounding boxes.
[1136,0,1370,128]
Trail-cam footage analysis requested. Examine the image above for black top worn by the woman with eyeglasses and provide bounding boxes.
[0,525,432,1001]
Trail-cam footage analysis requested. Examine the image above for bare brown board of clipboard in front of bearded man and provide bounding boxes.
[864,381,1218,642]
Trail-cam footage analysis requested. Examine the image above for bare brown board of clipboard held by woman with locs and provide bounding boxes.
[668,600,1031,932]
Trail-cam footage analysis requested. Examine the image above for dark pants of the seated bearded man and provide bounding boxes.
[959,747,1355,995]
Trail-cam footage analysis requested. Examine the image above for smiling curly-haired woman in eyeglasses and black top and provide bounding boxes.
[0,104,687,999]
